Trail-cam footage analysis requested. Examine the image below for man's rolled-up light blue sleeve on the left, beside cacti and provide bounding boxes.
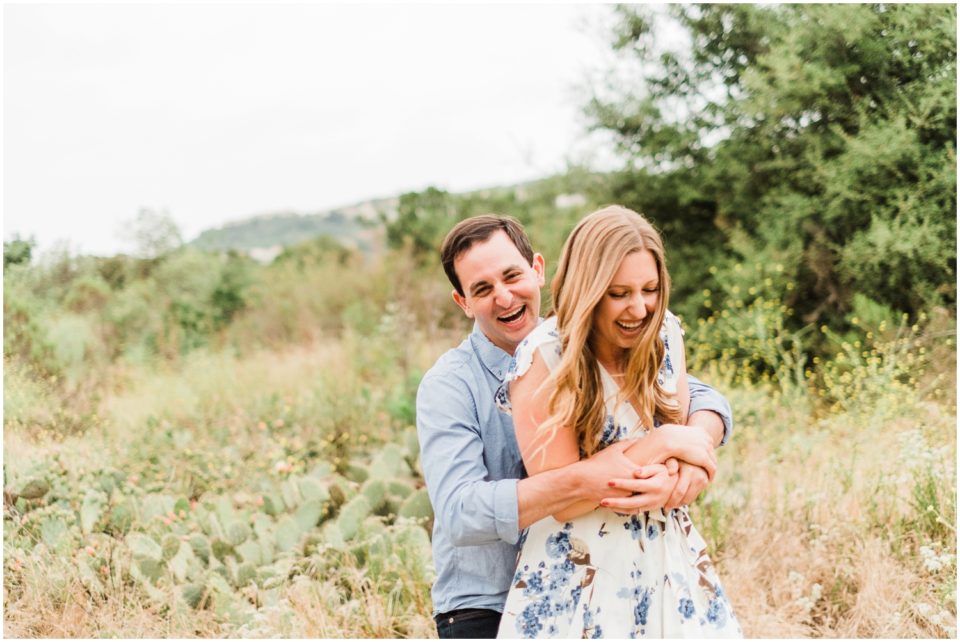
[417,372,520,546]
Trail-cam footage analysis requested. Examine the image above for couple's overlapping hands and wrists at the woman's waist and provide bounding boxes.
[593,424,717,513]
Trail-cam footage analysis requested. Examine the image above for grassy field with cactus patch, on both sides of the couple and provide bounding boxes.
[4,312,956,638]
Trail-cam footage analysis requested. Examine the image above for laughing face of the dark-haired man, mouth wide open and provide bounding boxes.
[453,231,544,354]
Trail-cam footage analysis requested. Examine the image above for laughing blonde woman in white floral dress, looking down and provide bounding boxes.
[498,206,742,638]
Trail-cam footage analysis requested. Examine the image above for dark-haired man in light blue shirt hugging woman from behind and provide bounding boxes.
[417,215,731,638]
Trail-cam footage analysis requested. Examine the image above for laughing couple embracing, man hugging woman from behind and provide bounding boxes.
[417,206,742,638]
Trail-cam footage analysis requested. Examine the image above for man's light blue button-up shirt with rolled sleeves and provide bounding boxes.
[417,324,733,615]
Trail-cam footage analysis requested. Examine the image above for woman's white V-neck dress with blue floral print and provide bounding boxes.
[497,312,743,638]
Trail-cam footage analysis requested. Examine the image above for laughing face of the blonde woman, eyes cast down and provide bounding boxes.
[593,250,660,363]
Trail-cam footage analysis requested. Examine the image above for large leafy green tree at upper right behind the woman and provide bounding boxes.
[588,4,957,325]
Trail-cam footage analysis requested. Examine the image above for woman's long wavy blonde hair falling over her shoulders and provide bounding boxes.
[537,205,681,456]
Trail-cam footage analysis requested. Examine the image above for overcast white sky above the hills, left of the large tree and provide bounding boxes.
[3,4,610,254]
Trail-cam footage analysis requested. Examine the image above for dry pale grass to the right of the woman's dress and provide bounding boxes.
[694,376,956,638]
